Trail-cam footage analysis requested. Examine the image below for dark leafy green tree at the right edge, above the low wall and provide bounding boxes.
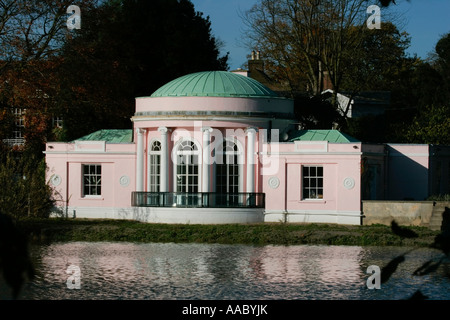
[388,34,450,144]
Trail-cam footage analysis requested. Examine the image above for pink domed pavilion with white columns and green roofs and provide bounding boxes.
[45,71,448,224]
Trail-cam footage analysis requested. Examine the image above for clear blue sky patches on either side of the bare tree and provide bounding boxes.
[191,0,450,70]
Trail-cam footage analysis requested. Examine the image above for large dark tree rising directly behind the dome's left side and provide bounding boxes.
[57,0,228,140]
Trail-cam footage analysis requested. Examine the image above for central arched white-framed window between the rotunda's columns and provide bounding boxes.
[175,140,200,193]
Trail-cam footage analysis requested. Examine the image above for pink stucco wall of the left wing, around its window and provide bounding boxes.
[46,142,136,211]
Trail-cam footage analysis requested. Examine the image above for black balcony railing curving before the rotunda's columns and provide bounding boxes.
[131,192,265,208]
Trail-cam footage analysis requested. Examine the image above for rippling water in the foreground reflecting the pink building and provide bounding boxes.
[0,242,450,300]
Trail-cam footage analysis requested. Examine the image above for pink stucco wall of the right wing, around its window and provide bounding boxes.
[263,142,361,224]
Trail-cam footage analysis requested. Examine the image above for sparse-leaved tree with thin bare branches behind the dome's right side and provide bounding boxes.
[244,0,404,120]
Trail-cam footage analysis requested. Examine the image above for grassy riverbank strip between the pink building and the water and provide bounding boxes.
[17,218,439,247]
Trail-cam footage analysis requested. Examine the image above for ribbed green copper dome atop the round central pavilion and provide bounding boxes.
[151,71,278,98]
